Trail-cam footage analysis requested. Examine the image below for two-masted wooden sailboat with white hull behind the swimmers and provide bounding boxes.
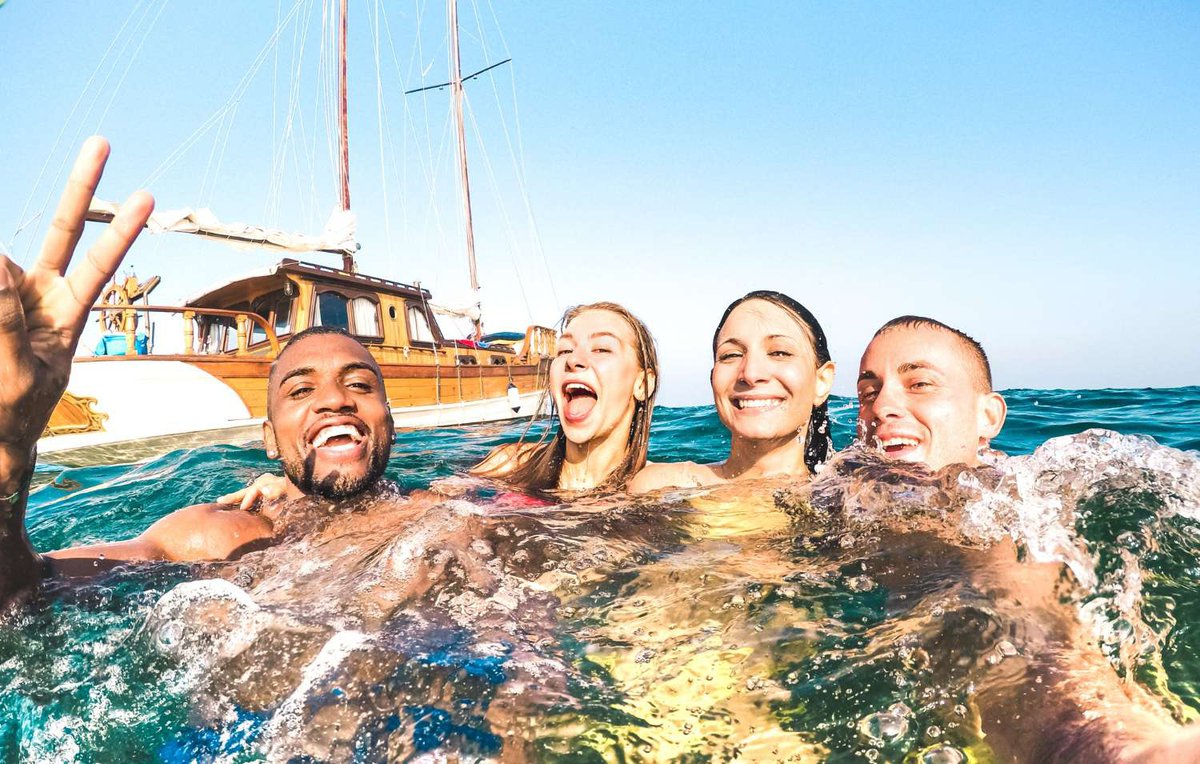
[38,0,556,465]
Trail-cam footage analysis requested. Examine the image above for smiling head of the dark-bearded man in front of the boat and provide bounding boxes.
[263,333,395,499]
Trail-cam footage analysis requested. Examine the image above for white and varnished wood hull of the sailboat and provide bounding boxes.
[38,355,548,465]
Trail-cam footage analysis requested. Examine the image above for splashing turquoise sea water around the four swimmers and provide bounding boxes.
[9,387,1200,762]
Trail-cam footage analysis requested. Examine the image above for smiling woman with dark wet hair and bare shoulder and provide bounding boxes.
[629,290,834,493]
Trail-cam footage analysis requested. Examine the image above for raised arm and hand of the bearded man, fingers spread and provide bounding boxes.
[0,137,154,604]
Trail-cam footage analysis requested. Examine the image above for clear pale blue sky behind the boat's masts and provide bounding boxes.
[0,0,1200,405]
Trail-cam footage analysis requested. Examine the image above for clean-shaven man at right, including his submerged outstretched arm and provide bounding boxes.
[858,315,1200,763]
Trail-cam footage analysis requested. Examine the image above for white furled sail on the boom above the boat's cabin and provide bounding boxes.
[88,198,359,255]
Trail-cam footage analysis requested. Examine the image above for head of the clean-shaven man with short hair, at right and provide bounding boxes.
[858,325,1007,470]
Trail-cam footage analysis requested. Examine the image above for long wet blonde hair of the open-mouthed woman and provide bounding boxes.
[480,302,659,493]
